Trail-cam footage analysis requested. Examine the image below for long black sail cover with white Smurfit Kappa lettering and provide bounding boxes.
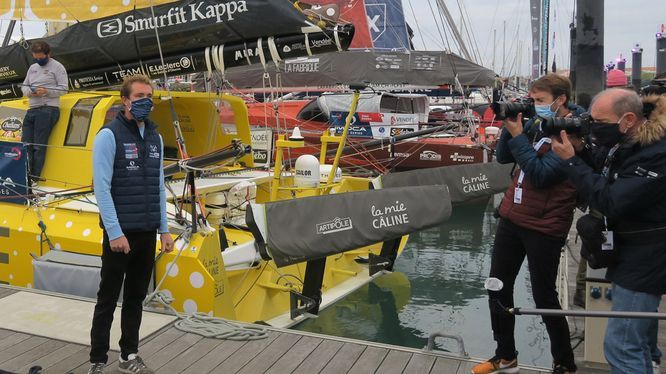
[0,0,353,99]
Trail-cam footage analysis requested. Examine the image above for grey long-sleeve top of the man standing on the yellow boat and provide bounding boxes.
[21,58,67,108]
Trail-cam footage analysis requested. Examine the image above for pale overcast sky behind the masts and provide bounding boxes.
[0,0,666,74]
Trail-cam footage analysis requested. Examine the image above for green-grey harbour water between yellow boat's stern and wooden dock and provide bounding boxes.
[295,195,560,367]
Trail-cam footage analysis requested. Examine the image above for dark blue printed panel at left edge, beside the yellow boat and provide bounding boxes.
[0,141,28,204]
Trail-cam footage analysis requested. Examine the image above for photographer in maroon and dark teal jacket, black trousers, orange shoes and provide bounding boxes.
[472,74,583,374]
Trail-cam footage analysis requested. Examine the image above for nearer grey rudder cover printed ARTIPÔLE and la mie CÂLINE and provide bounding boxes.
[254,186,451,267]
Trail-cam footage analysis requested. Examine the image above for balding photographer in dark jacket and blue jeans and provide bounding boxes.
[553,89,666,373]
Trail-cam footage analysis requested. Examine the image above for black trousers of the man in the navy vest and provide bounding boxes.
[90,231,157,363]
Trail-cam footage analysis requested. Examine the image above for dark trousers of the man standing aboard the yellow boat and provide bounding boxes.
[21,106,60,179]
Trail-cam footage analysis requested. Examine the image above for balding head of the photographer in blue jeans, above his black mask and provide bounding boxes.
[590,88,644,133]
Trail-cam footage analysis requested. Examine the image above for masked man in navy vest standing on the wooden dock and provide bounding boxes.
[88,75,173,374]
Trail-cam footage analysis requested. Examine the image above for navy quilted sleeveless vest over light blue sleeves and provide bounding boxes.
[103,113,162,232]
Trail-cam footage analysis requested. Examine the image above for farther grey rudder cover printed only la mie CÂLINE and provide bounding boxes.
[381,162,513,203]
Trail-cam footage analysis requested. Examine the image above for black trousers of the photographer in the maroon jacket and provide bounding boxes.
[488,219,576,370]
